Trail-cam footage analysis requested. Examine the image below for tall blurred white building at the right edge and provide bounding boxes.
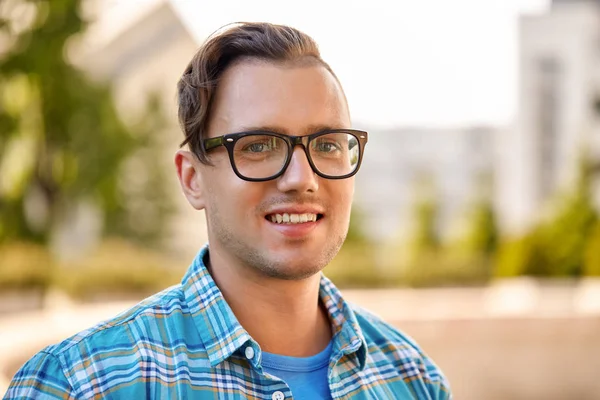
[496,0,600,236]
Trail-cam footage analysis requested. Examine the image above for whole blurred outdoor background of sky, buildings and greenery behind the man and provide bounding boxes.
[0,0,600,399]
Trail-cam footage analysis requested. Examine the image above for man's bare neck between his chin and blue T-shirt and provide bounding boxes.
[210,248,331,357]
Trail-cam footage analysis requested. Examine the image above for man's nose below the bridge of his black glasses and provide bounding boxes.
[277,146,319,193]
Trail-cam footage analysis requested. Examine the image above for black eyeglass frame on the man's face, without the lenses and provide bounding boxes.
[202,129,369,182]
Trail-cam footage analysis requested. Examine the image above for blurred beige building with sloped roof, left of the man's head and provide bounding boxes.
[76,0,207,259]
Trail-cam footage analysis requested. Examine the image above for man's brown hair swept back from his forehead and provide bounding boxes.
[177,23,337,164]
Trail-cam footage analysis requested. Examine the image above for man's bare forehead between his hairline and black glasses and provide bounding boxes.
[209,60,350,136]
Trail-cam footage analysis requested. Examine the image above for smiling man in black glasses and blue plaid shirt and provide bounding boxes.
[7,23,450,400]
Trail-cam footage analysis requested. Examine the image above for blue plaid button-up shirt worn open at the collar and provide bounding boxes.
[5,247,451,400]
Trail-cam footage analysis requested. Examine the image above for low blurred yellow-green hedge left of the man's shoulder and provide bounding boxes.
[0,239,187,300]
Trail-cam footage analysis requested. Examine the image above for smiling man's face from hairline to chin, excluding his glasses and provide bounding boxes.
[198,61,354,279]
